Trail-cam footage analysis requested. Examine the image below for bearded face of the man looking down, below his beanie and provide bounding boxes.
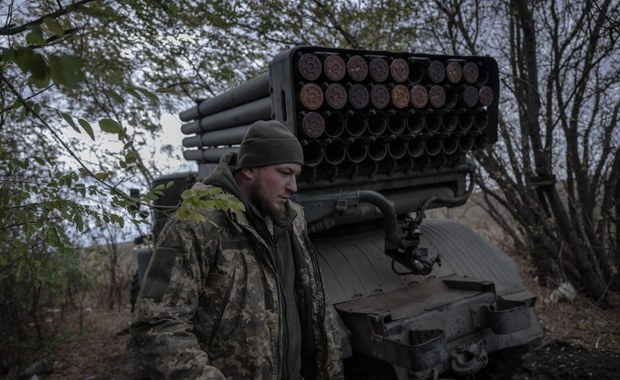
[250,163,301,219]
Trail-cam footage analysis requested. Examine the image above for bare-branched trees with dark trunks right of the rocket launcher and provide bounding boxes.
[426,1,620,305]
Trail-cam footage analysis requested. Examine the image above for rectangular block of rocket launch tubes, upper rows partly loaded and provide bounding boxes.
[180,47,499,180]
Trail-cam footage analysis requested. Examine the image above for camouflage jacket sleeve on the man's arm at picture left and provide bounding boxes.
[130,220,225,380]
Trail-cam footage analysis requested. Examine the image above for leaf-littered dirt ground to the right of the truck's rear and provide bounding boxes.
[502,254,620,380]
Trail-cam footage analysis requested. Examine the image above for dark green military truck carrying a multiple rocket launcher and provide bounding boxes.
[136,46,542,379]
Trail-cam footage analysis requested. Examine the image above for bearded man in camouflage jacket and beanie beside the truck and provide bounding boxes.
[131,121,343,379]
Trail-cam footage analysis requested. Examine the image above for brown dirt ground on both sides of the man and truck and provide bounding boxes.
[12,256,620,380]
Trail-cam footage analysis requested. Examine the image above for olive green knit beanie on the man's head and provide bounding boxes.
[237,120,304,169]
